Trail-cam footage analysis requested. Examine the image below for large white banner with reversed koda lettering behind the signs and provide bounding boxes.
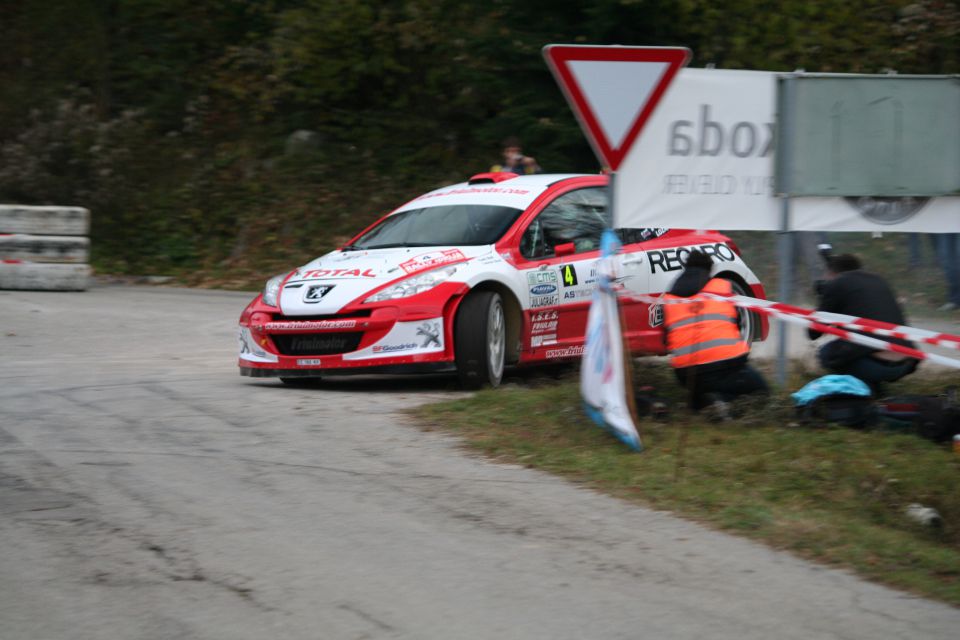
[614,69,960,233]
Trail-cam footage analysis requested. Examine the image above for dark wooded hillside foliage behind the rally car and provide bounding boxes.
[0,0,960,270]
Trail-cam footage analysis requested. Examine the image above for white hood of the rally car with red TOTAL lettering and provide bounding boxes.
[280,245,493,316]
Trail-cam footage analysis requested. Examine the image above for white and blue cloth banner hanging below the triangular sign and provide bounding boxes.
[580,229,643,451]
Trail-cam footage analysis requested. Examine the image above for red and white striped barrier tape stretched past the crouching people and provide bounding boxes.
[623,293,960,369]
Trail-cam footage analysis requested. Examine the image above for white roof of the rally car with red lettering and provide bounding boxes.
[394,173,590,213]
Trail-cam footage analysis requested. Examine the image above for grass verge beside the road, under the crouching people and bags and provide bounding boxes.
[415,363,960,605]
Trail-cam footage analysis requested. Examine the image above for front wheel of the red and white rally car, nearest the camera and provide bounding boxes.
[453,291,507,389]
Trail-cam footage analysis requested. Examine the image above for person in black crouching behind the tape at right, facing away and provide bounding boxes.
[808,253,918,395]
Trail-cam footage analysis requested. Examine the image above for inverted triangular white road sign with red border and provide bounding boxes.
[543,44,690,171]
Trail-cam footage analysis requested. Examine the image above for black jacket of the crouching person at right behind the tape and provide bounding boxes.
[808,269,915,360]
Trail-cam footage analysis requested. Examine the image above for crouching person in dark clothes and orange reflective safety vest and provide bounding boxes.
[663,251,769,415]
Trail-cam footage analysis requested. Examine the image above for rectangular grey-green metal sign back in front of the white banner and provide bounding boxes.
[776,74,960,197]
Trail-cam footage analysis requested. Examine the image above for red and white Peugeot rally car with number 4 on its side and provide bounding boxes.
[239,173,767,388]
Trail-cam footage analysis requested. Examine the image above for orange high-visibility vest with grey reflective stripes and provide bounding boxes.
[663,278,750,369]
